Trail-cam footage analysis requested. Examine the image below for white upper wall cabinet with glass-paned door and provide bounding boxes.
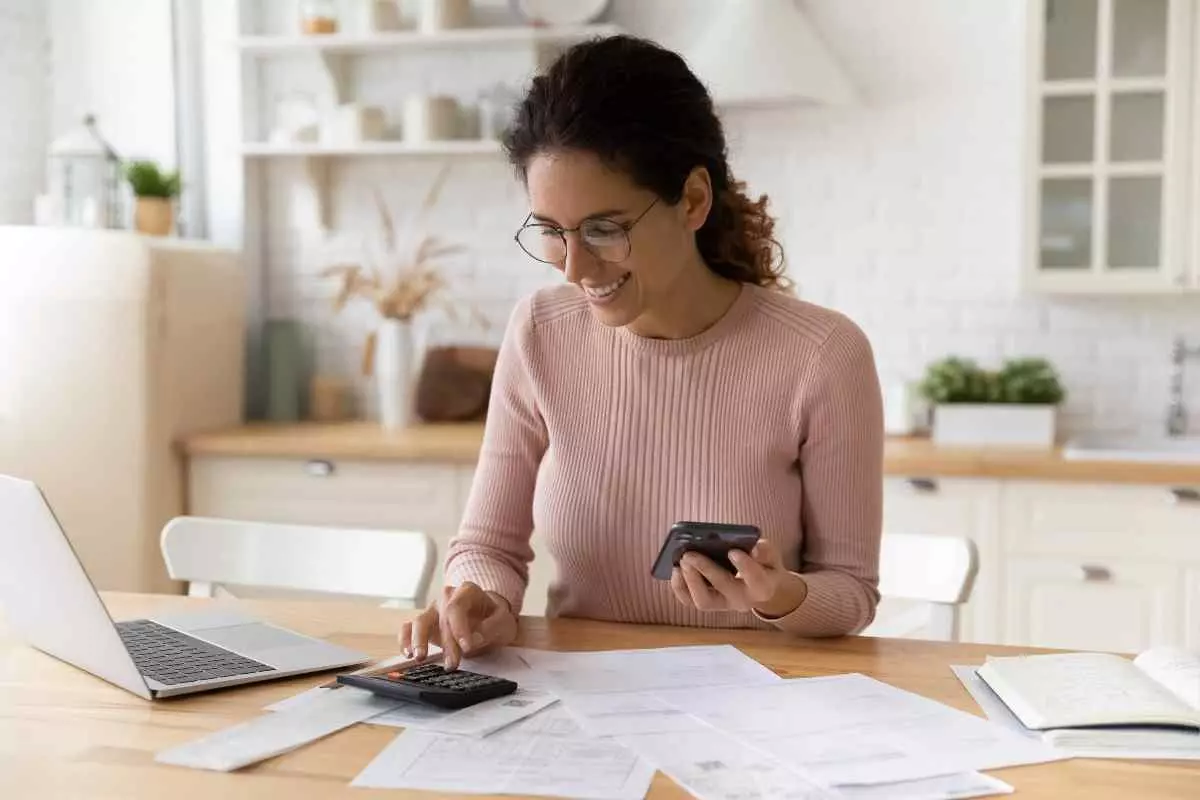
[1024,0,1200,294]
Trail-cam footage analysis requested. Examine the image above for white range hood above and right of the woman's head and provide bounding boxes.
[684,0,857,106]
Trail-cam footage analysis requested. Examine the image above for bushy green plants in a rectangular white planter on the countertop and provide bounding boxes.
[920,356,1066,447]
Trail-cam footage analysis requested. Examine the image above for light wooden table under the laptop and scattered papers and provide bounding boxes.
[0,594,1200,800]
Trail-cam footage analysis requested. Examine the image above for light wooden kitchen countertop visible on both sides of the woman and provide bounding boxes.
[181,422,1200,486]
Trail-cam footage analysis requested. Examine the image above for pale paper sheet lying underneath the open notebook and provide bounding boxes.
[950,664,1200,760]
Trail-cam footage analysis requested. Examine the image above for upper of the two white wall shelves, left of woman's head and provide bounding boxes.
[236,25,620,55]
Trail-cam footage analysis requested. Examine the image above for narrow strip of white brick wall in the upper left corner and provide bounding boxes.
[0,0,49,224]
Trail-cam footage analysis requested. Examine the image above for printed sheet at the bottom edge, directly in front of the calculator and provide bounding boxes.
[352,705,654,800]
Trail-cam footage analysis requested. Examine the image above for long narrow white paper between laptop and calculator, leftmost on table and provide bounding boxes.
[155,692,395,771]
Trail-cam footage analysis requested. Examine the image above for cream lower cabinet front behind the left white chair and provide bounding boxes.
[188,456,553,615]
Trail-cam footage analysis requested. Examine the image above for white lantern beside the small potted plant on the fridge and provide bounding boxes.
[48,114,125,228]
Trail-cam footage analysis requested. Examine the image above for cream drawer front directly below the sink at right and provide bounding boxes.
[1001,482,1200,564]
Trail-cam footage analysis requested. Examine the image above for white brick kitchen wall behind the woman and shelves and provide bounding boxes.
[243,0,1200,432]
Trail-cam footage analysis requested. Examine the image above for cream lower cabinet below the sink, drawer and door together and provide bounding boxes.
[998,481,1200,652]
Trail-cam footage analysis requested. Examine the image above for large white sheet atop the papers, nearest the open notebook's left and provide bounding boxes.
[661,674,1062,786]
